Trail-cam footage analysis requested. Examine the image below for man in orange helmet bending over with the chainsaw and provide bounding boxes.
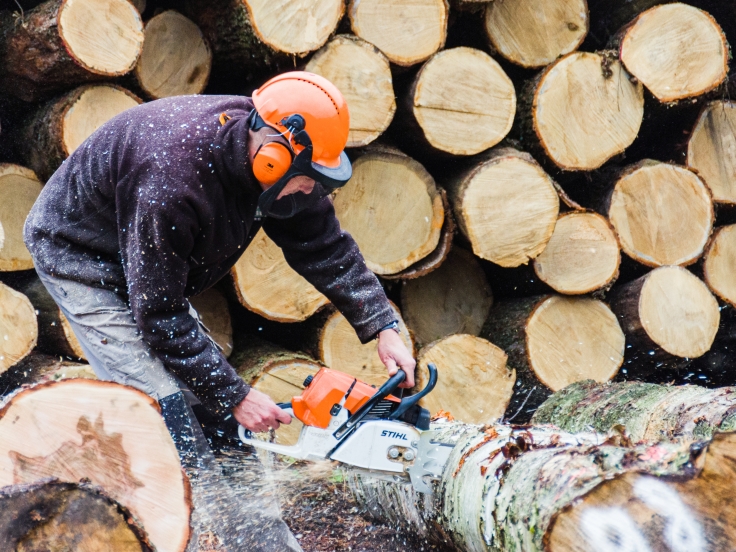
[25,72,415,462]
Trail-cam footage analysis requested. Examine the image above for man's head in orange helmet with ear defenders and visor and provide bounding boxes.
[249,71,352,218]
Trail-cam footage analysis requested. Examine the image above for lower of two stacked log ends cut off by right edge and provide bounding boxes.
[703,224,736,306]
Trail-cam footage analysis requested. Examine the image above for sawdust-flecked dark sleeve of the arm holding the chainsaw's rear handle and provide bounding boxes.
[118,177,250,415]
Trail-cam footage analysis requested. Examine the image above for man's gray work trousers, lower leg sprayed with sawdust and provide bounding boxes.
[36,268,302,552]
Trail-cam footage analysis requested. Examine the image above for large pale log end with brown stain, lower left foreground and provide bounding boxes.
[0,379,192,552]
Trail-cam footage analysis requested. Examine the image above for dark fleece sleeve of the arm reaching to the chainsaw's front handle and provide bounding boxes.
[263,197,396,343]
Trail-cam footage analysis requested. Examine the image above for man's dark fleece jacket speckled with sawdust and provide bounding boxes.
[25,96,394,413]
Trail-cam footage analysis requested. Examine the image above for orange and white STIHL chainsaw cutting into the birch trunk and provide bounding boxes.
[238,364,452,494]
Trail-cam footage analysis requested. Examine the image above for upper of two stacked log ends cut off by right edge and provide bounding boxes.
[687,101,736,205]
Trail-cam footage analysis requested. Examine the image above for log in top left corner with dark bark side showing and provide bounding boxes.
[0,0,143,101]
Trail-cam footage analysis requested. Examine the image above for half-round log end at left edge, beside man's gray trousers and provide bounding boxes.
[0,283,38,374]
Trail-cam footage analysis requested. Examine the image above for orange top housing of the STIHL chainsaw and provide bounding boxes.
[291,368,400,429]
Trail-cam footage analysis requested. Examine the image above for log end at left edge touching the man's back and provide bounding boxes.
[0,163,43,271]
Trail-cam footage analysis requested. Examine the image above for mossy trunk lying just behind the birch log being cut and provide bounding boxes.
[532,381,736,443]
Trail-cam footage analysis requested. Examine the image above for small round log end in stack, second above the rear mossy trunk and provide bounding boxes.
[534,212,621,295]
